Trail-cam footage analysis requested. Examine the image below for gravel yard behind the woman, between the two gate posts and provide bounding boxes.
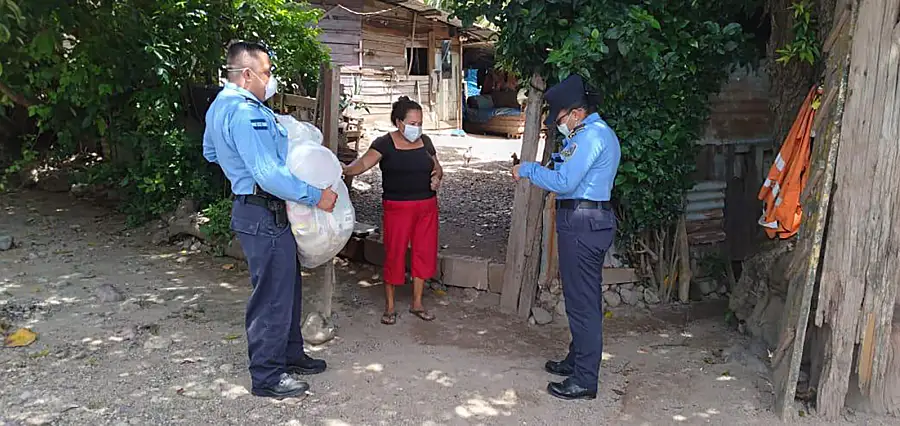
[351,132,521,261]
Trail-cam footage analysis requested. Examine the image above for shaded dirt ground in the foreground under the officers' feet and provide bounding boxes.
[0,193,895,426]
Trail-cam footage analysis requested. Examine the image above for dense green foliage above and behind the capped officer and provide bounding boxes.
[446,0,752,240]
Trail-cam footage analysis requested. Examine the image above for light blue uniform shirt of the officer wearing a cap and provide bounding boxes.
[519,113,622,201]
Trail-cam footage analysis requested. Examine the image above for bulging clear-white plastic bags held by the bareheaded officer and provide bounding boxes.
[277,115,356,268]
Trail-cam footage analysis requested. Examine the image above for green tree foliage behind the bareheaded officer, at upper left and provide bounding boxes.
[0,0,327,225]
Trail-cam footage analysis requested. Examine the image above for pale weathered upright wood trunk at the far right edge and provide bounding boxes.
[816,0,900,419]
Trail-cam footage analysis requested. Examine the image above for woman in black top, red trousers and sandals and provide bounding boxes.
[344,96,443,325]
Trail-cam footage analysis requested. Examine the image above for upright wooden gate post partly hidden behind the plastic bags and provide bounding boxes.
[301,65,341,344]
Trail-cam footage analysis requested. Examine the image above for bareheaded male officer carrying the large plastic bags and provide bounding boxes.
[203,42,337,398]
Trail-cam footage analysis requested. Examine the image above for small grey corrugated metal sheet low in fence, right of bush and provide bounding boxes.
[685,181,728,244]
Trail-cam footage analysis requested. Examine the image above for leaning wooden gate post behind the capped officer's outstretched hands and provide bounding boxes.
[500,73,551,318]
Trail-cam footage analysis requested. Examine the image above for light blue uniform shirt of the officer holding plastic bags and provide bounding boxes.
[203,83,322,206]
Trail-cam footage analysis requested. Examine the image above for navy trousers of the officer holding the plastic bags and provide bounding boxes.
[231,196,303,388]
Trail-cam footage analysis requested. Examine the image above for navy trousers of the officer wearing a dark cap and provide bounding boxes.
[556,205,616,390]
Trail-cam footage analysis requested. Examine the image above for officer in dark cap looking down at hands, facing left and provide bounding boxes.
[513,75,621,399]
